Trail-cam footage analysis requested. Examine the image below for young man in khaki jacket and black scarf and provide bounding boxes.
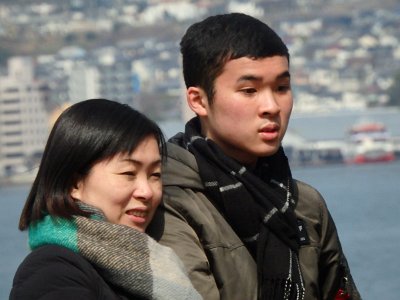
[149,13,359,300]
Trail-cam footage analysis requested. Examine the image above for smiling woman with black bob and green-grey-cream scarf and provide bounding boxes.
[10,99,200,300]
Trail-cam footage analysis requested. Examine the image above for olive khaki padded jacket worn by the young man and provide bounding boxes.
[148,143,359,300]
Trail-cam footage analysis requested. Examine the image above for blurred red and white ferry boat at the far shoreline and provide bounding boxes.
[346,122,396,164]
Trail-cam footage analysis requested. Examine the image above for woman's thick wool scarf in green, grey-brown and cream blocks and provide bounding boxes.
[29,209,201,299]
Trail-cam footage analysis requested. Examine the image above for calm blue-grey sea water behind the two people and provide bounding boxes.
[0,161,400,300]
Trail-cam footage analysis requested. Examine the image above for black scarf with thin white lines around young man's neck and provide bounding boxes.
[171,118,304,300]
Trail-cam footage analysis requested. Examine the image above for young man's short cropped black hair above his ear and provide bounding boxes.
[180,13,289,104]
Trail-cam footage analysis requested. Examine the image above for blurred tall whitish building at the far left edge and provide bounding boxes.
[0,57,48,176]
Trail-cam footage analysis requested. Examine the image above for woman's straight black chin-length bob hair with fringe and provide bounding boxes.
[19,99,166,230]
